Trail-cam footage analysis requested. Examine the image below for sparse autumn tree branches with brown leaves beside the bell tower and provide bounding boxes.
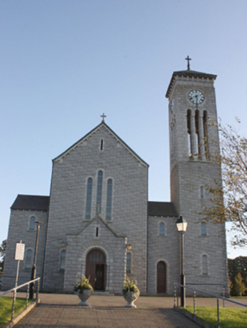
[203,120,247,246]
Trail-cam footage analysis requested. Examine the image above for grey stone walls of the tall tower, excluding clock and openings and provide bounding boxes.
[169,77,228,293]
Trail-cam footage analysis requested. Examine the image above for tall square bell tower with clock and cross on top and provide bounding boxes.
[166,56,227,292]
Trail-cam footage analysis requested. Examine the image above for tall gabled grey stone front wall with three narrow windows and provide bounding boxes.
[44,124,148,292]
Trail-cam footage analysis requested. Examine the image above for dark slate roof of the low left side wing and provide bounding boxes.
[11,195,50,212]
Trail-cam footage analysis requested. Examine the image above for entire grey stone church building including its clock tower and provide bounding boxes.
[3,64,228,295]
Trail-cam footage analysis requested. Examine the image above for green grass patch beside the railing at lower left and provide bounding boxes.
[0,296,31,327]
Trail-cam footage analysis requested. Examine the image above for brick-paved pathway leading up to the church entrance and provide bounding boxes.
[15,294,203,328]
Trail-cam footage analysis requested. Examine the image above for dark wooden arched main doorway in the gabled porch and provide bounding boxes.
[86,248,106,290]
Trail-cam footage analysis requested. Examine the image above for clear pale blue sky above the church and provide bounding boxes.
[0,0,247,258]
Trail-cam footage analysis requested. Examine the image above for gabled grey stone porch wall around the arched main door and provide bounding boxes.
[64,218,127,294]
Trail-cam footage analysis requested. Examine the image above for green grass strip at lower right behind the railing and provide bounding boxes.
[186,306,247,328]
